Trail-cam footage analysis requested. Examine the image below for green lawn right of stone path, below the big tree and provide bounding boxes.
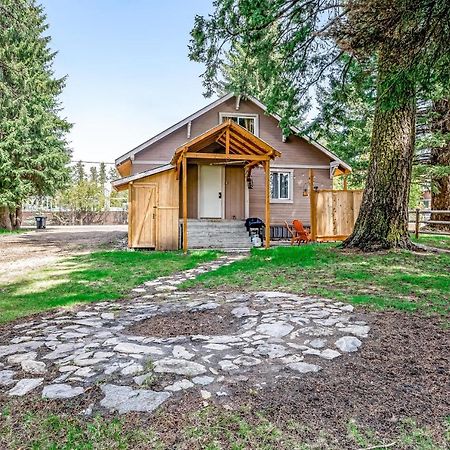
[181,244,450,315]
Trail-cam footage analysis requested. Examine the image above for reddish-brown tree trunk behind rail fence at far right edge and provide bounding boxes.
[430,99,450,230]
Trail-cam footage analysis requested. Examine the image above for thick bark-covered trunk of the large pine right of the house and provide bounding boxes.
[344,51,416,251]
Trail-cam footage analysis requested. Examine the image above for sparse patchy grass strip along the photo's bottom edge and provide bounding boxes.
[0,405,450,450]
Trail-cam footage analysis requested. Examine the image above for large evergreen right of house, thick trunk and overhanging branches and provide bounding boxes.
[189,0,450,250]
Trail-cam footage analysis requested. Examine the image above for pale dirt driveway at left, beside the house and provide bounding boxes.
[0,225,127,283]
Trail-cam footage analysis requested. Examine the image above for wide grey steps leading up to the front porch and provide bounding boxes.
[184,219,251,249]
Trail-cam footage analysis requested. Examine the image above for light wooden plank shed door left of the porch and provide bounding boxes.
[128,184,158,248]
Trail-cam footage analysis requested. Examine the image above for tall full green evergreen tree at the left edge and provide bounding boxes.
[0,0,70,229]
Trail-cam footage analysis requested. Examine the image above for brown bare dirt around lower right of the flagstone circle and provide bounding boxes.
[0,312,450,450]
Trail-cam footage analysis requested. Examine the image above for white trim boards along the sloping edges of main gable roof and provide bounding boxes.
[115,94,352,171]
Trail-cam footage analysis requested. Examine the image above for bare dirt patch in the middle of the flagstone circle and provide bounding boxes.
[126,306,239,337]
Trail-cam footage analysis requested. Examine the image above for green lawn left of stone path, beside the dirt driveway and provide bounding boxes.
[0,251,217,322]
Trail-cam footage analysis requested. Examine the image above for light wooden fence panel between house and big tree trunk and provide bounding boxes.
[311,189,363,241]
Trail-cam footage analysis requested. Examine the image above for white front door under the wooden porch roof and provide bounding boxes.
[199,165,224,219]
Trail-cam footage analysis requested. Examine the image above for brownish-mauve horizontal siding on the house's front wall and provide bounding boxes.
[132,98,332,224]
